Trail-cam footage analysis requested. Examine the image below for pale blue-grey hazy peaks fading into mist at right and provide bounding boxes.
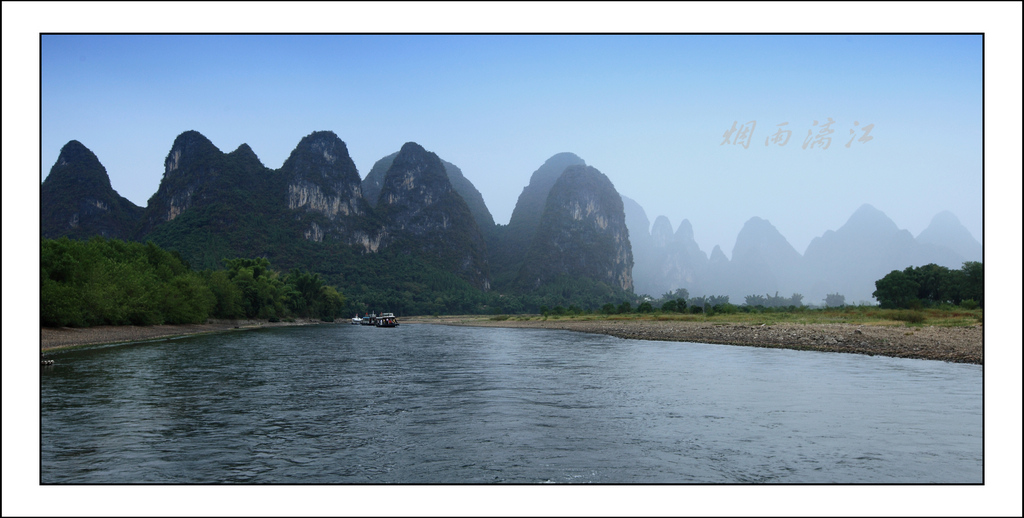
[626,198,982,305]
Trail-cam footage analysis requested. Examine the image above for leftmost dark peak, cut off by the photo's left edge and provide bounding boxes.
[40,140,143,240]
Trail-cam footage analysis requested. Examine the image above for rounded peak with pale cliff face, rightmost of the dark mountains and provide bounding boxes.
[518,165,633,291]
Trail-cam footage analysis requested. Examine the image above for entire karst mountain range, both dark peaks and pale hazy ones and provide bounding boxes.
[40,131,981,308]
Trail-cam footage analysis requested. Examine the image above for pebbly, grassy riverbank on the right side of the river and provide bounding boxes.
[402,316,984,364]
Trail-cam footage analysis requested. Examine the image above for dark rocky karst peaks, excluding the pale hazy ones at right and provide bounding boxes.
[41,131,633,311]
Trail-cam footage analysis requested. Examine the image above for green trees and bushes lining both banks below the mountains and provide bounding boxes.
[40,236,984,327]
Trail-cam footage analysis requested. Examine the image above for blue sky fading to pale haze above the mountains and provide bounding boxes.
[41,35,982,256]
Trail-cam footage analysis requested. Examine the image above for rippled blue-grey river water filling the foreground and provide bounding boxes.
[41,325,982,484]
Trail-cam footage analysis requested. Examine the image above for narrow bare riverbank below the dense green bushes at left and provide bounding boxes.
[40,319,330,352]
